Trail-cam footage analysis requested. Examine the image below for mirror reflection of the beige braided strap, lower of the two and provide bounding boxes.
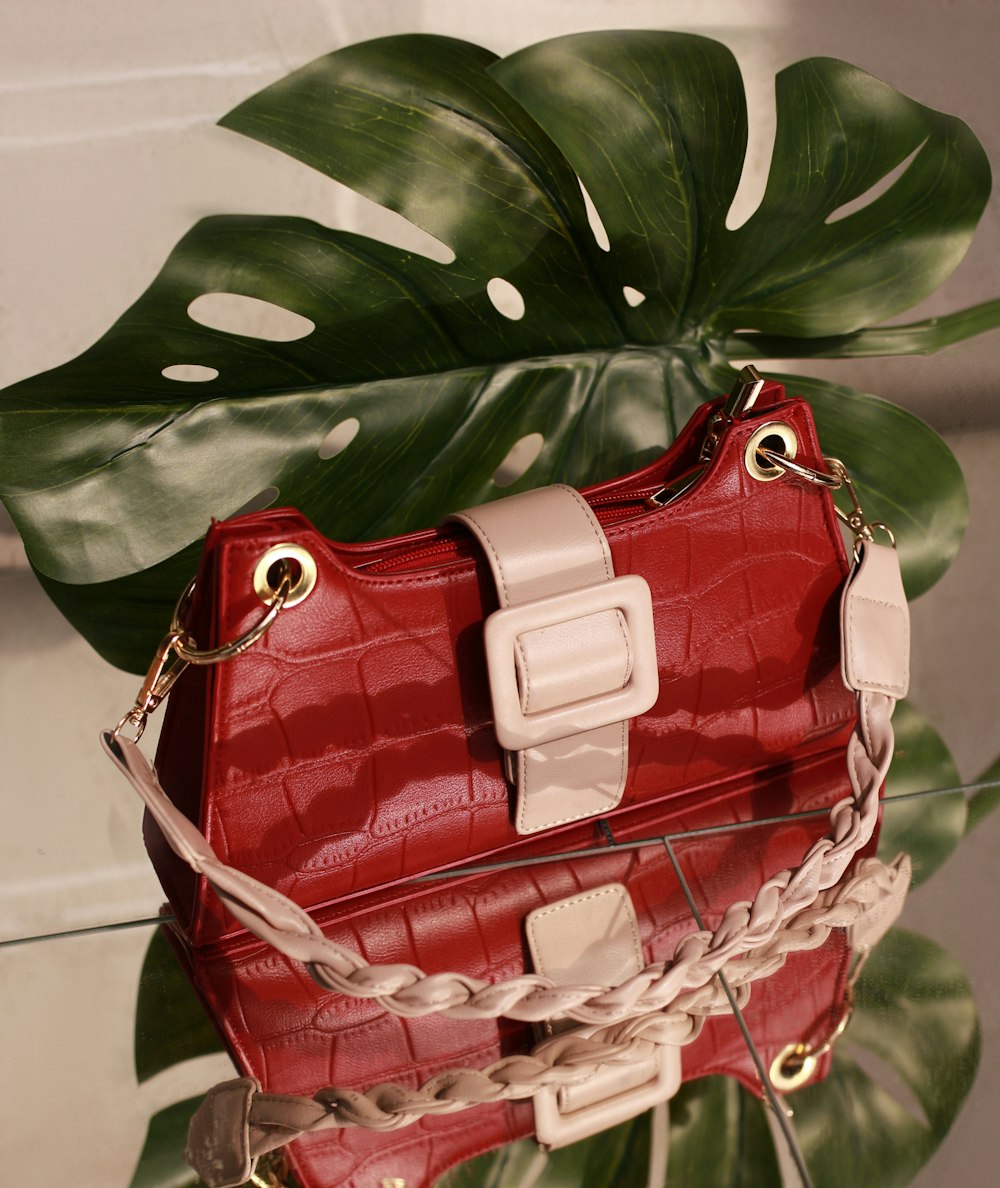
[185,855,911,1188]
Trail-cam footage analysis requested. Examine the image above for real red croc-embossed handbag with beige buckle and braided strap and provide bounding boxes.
[105,365,907,1183]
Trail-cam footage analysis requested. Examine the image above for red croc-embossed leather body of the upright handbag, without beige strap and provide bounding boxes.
[146,385,854,950]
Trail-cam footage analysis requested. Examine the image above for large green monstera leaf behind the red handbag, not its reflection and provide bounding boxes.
[0,32,1000,669]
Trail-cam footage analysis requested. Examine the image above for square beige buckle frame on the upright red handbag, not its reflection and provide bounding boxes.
[483,574,659,751]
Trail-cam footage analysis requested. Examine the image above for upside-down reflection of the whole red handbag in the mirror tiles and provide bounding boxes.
[175,798,909,1188]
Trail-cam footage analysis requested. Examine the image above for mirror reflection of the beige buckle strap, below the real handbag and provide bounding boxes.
[525,883,681,1148]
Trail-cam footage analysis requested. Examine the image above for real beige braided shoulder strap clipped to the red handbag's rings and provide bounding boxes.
[101,543,909,1024]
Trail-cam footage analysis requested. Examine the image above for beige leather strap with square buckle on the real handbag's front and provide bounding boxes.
[451,486,659,834]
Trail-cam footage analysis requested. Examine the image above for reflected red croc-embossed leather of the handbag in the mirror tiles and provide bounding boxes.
[179,756,849,1188]
